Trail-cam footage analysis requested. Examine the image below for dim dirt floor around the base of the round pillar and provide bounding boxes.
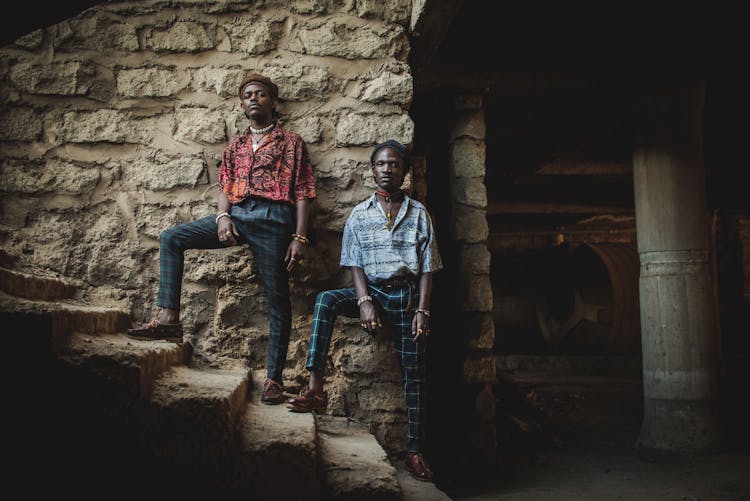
[444,436,750,501]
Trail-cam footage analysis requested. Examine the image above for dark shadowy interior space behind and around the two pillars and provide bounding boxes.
[410,0,750,488]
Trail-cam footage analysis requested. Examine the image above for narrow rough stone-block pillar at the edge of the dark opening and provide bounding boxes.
[450,95,497,460]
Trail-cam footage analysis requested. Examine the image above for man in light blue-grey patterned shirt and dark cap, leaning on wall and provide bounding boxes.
[287,140,442,482]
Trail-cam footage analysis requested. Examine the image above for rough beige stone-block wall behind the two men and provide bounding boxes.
[0,0,414,451]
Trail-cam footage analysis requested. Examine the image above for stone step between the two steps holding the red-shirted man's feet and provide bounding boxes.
[133,366,253,492]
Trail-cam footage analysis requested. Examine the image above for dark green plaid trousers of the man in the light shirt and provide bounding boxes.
[305,284,427,452]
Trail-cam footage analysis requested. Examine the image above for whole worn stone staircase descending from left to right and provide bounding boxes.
[0,268,448,499]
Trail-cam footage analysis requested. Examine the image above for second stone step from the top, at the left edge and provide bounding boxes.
[0,292,130,353]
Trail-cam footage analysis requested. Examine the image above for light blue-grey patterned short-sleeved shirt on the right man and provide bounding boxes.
[340,193,443,283]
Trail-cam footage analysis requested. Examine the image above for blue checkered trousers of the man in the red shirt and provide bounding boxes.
[157,198,296,381]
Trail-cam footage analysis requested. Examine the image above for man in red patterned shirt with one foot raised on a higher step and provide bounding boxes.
[128,73,316,404]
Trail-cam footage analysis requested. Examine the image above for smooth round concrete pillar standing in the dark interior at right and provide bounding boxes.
[633,81,719,451]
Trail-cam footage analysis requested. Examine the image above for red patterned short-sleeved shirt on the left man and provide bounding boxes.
[219,123,315,204]
